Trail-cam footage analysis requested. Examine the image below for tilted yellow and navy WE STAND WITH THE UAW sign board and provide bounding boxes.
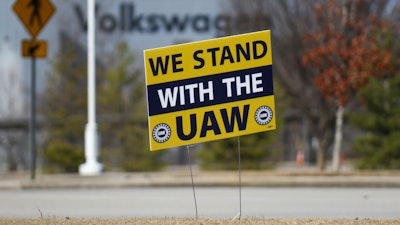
[144,30,276,150]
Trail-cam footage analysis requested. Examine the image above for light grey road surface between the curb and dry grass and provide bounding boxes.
[0,187,400,219]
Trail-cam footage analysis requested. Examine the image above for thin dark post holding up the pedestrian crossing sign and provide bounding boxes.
[29,52,36,180]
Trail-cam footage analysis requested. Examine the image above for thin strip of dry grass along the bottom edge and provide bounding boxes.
[0,218,400,225]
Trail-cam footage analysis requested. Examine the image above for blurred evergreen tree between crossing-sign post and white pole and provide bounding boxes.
[38,34,87,173]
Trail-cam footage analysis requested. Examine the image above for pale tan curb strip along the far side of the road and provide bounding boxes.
[0,171,400,190]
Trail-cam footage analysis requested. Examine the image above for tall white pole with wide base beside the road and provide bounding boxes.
[79,0,103,176]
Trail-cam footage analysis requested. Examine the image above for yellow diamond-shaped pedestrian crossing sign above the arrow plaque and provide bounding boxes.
[13,0,55,38]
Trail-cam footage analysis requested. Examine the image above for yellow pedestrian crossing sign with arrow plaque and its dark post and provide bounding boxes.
[13,0,55,180]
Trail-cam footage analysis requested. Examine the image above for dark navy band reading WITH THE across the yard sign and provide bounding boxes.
[147,65,273,116]
